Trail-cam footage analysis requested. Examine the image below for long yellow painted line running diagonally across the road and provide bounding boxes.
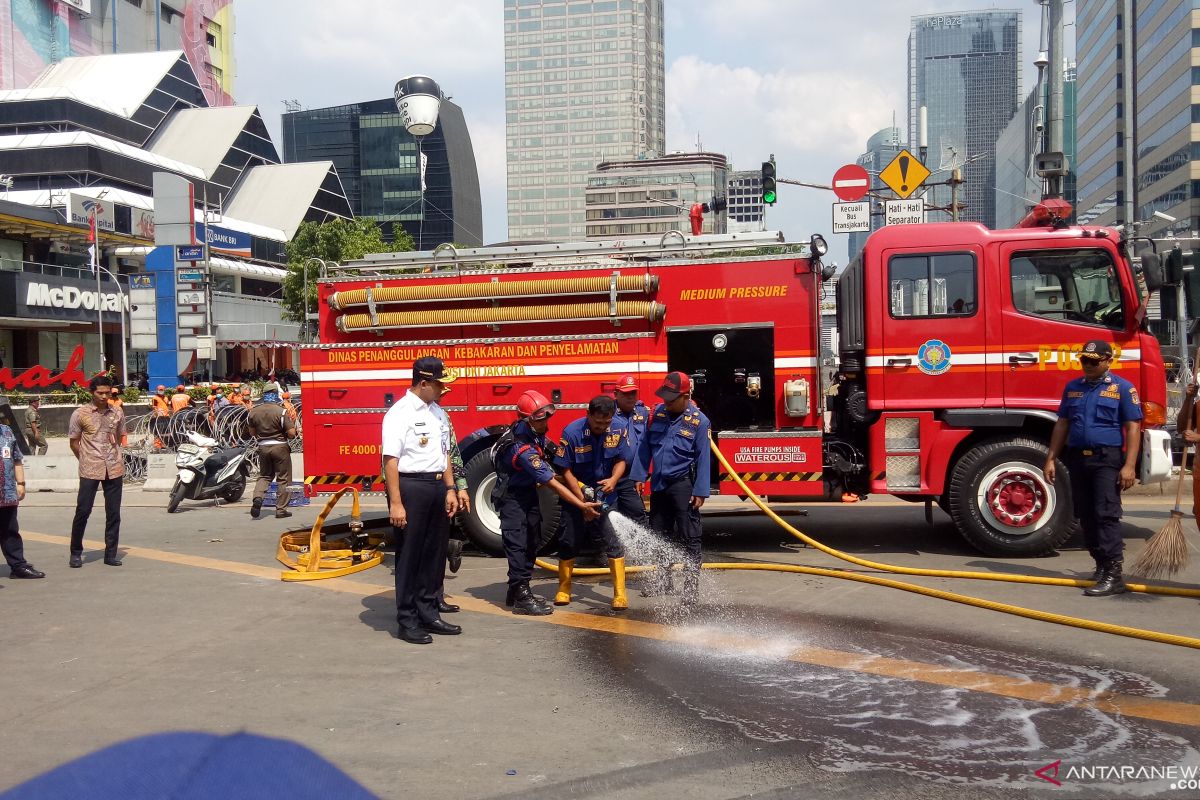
[22,531,1200,728]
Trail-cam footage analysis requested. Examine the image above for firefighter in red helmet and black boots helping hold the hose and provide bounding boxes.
[492,390,600,616]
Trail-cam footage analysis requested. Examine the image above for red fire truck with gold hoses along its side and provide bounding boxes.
[301,209,1170,555]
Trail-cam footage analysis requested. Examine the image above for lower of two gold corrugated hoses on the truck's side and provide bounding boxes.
[337,300,667,333]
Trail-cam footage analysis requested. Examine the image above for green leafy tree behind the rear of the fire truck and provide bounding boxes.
[283,217,413,323]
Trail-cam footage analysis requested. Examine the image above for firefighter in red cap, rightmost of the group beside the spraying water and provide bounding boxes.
[638,372,710,604]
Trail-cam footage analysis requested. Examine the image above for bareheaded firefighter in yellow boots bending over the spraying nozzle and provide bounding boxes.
[554,395,641,610]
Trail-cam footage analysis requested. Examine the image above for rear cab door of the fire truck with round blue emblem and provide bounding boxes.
[868,247,1000,409]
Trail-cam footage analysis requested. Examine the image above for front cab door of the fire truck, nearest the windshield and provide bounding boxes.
[997,240,1140,410]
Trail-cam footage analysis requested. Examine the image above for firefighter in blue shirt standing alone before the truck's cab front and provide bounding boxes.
[1043,339,1142,597]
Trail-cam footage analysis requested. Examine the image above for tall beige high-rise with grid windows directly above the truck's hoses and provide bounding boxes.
[504,0,666,241]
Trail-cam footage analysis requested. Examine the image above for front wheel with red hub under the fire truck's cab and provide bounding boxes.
[947,437,1079,558]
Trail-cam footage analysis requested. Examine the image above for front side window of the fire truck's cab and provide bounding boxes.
[1009,248,1126,330]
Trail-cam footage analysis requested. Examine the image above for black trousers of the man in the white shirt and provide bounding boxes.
[396,474,450,628]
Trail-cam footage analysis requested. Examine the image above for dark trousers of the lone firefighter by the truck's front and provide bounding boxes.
[1066,447,1124,560]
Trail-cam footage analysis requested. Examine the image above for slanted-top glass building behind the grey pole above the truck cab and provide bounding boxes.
[996,65,1078,228]
